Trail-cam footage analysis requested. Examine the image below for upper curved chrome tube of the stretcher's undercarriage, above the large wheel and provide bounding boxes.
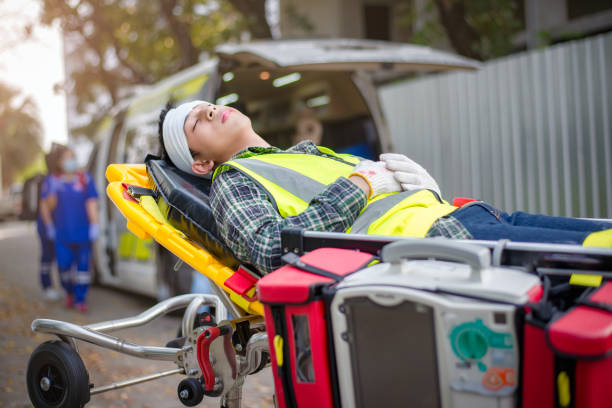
[85,293,215,332]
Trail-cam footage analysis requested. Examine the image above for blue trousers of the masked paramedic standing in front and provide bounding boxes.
[55,239,91,303]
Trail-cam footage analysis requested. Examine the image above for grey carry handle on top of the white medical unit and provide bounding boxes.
[382,239,491,277]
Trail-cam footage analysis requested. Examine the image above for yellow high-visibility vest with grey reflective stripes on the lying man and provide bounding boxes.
[213,147,457,238]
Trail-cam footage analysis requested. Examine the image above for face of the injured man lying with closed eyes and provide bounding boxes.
[184,103,251,164]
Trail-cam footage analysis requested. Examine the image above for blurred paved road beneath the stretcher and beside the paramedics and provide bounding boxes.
[0,222,273,408]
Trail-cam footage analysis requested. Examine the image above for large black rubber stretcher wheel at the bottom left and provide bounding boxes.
[26,341,89,408]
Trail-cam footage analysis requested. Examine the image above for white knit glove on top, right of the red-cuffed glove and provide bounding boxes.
[380,153,442,197]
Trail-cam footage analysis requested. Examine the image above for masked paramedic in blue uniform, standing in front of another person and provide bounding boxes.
[43,148,99,312]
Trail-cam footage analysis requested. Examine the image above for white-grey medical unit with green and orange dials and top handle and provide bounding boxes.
[330,241,541,408]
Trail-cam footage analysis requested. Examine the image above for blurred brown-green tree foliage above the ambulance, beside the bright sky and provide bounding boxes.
[41,0,269,137]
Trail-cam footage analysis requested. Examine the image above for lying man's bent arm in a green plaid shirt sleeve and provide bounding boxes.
[211,170,367,273]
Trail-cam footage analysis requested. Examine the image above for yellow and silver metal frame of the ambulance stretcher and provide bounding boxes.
[27,164,612,407]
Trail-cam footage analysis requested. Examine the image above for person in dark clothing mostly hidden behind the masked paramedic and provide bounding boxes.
[36,153,60,300]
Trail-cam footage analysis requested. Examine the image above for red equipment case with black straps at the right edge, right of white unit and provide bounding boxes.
[522,282,612,408]
